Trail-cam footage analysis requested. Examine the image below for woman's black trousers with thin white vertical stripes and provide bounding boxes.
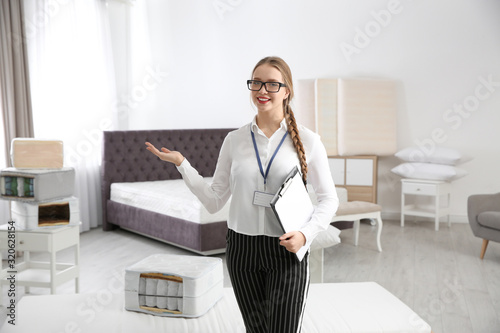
[226,229,309,333]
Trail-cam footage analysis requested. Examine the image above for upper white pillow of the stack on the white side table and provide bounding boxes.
[395,147,472,165]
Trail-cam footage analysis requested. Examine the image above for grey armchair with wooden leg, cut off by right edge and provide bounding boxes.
[467,193,500,259]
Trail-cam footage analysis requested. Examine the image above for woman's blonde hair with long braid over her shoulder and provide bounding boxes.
[252,57,307,184]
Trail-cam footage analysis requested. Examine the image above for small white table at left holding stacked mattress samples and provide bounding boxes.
[0,224,80,305]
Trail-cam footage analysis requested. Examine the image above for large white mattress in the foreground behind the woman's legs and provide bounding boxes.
[2,282,431,333]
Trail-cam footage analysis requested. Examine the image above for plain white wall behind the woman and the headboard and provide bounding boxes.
[111,0,500,221]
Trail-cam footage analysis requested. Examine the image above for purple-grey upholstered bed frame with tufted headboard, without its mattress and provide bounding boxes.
[101,129,236,255]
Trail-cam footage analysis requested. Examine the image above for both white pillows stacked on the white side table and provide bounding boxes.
[391,147,472,181]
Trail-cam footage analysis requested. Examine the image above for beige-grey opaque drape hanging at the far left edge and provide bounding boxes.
[0,0,33,224]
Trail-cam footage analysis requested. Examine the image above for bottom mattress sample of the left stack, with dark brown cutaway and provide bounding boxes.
[11,197,80,230]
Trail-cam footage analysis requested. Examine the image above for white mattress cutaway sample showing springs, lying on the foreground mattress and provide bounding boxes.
[125,254,223,317]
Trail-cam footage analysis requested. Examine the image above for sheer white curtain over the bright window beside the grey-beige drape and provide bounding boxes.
[24,0,117,231]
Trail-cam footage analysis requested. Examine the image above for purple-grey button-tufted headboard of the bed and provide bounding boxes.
[101,129,232,230]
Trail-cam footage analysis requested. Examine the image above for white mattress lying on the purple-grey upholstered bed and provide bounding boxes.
[111,177,230,224]
